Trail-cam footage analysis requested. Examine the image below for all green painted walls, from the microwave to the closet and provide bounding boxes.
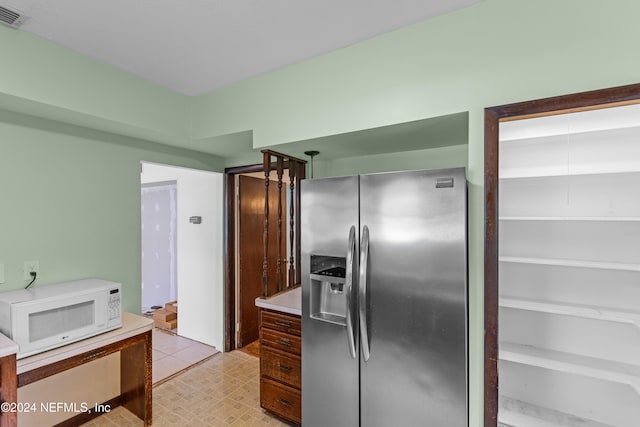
[0,0,640,426]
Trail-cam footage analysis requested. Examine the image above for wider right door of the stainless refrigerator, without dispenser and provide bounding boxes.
[358,168,467,427]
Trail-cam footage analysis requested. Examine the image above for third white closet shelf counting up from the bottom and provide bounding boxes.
[500,297,640,329]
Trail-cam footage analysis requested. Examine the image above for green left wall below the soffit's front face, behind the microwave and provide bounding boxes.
[0,110,222,312]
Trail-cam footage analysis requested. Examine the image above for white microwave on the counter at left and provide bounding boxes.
[0,279,122,359]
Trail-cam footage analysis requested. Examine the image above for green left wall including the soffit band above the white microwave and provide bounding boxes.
[0,20,224,312]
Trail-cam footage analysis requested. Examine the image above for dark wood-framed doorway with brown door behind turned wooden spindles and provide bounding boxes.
[224,155,306,351]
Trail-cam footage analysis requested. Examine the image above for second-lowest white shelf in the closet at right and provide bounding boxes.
[499,342,640,396]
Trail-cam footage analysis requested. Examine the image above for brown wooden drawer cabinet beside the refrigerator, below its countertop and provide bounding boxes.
[260,309,302,424]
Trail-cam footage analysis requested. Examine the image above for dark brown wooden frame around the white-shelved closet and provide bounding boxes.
[484,84,640,427]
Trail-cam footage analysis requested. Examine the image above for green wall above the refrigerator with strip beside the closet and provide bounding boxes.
[192,0,640,427]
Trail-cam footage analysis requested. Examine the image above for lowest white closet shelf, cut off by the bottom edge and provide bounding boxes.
[498,396,611,427]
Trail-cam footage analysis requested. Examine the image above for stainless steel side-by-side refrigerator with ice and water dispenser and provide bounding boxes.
[301,168,468,427]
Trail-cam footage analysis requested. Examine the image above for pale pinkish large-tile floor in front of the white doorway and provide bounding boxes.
[153,328,218,384]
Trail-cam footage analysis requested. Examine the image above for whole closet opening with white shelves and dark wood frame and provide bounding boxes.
[484,84,640,426]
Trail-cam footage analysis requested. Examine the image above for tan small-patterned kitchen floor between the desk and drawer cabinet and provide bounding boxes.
[84,351,290,427]
